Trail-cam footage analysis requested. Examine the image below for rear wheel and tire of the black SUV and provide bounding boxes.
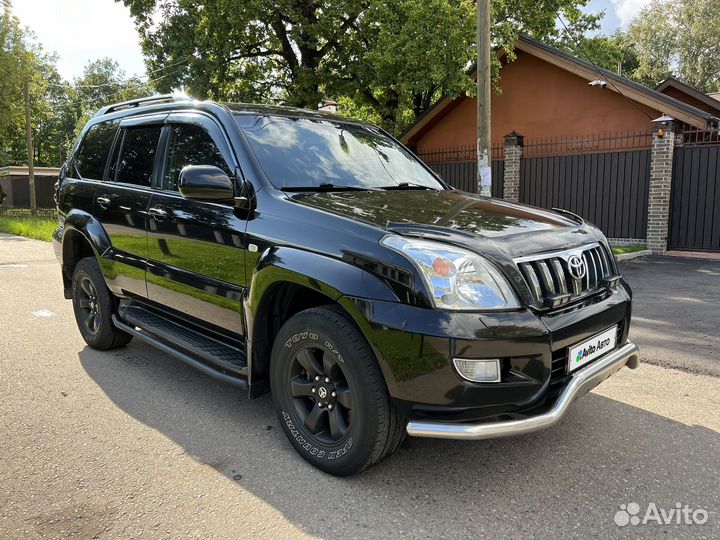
[71,257,132,351]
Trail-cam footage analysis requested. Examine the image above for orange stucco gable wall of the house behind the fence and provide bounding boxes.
[410,51,660,152]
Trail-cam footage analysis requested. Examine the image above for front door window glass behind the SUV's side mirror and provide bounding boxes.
[163,124,230,191]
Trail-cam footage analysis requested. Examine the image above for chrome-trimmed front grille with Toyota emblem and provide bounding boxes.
[515,244,617,307]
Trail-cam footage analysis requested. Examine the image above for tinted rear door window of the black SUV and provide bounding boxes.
[116,126,161,186]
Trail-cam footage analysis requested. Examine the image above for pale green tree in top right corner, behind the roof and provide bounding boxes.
[627,0,720,92]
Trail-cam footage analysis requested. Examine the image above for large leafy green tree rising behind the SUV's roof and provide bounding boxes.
[116,0,597,132]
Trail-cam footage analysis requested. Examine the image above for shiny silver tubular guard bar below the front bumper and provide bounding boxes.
[407,342,640,440]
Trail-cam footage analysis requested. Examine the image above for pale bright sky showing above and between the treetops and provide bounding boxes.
[13,0,650,80]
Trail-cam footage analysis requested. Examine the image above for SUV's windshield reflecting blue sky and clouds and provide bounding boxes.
[235,115,445,190]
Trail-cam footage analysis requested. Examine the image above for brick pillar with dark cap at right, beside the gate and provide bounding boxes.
[647,116,676,255]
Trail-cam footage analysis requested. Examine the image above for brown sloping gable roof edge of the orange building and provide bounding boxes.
[401,34,720,143]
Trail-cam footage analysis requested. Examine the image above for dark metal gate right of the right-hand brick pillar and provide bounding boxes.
[668,144,720,251]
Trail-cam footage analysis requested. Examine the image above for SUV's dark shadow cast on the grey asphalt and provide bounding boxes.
[79,341,720,538]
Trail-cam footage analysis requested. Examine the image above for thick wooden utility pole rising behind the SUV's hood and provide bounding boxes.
[477,0,492,197]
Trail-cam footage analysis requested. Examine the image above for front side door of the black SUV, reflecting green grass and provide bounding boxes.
[147,113,246,335]
